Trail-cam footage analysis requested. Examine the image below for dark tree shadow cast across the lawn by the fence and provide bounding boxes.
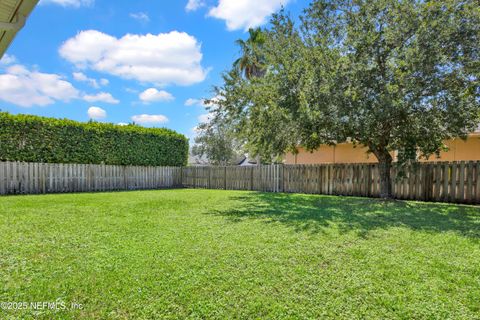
[210,193,480,239]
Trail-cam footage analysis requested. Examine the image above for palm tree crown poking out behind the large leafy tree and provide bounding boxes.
[233,28,265,79]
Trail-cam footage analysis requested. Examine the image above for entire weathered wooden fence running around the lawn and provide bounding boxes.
[0,161,480,204]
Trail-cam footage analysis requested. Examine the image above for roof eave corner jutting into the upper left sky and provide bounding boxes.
[0,0,38,58]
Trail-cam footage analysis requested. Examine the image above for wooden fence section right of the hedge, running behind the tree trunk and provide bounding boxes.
[182,161,480,204]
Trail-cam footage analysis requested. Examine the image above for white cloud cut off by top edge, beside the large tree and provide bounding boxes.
[208,0,290,30]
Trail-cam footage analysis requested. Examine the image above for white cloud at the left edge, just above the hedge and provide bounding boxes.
[0,64,79,107]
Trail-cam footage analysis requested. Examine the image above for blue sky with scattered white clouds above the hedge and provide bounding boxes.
[0,0,308,138]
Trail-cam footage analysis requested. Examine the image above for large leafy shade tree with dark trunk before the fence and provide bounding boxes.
[212,0,480,198]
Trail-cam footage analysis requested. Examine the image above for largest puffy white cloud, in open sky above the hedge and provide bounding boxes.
[60,30,207,86]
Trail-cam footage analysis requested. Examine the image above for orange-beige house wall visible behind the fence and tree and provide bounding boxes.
[285,130,480,164]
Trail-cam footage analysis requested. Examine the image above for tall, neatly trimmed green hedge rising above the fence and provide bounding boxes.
[0,112,188,166]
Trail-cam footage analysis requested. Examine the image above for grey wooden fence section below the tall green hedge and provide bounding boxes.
[0,162,182,194]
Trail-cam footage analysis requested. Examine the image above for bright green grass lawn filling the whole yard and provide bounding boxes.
[0,190,480,319]
